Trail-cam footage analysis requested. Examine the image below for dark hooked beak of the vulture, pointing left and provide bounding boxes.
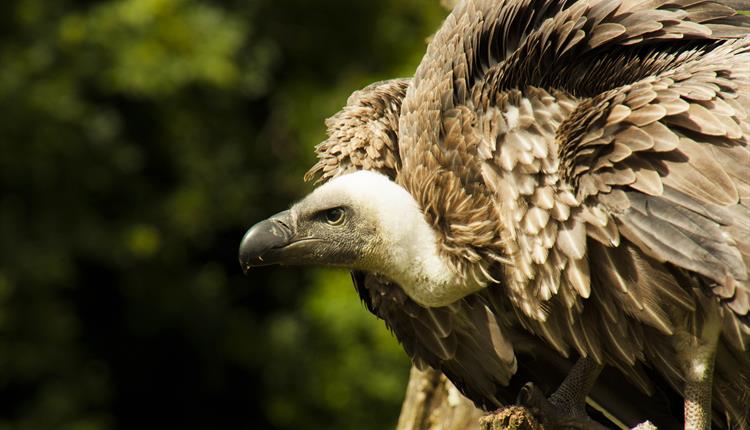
[239,210,318,273]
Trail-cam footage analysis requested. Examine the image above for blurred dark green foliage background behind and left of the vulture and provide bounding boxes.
[0,0,446,430]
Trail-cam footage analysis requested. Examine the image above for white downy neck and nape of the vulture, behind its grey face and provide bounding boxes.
[347,172,485,307]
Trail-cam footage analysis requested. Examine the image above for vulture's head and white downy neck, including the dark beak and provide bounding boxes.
[244,171,483,306]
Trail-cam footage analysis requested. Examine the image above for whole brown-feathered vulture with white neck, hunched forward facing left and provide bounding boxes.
[239,0,750,429]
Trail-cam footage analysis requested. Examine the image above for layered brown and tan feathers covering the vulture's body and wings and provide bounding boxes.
[310,0,750,428]
